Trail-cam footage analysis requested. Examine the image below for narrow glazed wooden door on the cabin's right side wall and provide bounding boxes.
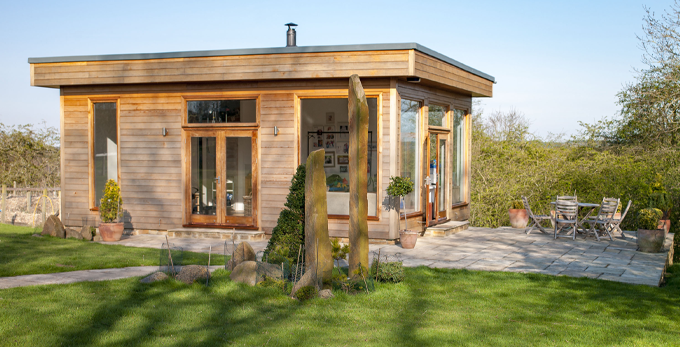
[425,131,448,226]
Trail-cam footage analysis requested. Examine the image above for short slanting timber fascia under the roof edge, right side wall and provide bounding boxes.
[414,51,493,97]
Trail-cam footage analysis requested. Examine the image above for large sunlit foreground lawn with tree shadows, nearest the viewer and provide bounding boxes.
[0,266,680,347]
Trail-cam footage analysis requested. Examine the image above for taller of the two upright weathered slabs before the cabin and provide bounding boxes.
[348,75,368,274]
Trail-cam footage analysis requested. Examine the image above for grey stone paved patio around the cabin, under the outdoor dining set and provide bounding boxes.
[106,227,673,286]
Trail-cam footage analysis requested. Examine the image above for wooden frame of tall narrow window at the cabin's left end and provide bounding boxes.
[87,97,121,211]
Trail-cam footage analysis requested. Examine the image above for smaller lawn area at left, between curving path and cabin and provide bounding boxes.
[0,224,224,277]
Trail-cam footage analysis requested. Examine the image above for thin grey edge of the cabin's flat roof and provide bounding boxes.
[28,42,496,82]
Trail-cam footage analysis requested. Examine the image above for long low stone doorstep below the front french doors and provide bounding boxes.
[131,228,267,241]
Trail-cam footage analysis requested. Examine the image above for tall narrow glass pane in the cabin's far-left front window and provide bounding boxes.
[94,102,118,206]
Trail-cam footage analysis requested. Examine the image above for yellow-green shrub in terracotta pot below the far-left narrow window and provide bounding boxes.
[99,180,123,242]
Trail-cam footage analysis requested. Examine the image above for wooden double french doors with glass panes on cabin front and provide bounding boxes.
[184,130,258,227]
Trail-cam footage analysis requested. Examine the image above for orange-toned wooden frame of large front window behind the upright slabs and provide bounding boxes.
[294,93,384,221]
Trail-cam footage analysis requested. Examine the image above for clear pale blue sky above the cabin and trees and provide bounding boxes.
[0,0,672,135]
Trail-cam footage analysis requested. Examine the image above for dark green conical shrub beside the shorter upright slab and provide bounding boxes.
[263,165,305,263]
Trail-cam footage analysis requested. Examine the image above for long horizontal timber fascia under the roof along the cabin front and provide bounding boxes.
[31,50,409,87]
